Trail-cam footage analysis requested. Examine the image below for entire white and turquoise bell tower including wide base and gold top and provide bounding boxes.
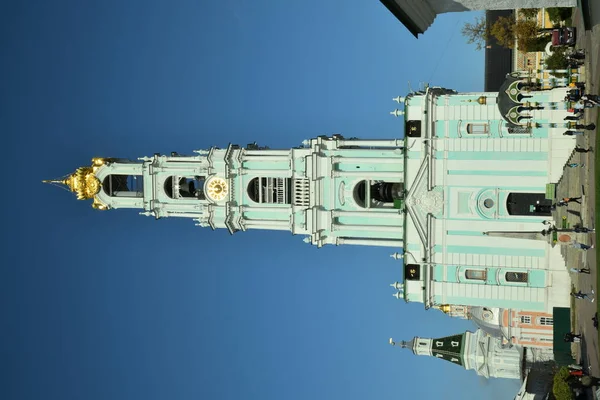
[50,76,575,313]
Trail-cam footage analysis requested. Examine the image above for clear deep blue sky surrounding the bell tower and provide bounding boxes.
[0,0,518,400]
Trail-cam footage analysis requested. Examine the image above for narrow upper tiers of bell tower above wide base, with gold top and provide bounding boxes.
[45,135,405,247]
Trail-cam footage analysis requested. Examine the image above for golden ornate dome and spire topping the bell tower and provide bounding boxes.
[42,158,108,210]
